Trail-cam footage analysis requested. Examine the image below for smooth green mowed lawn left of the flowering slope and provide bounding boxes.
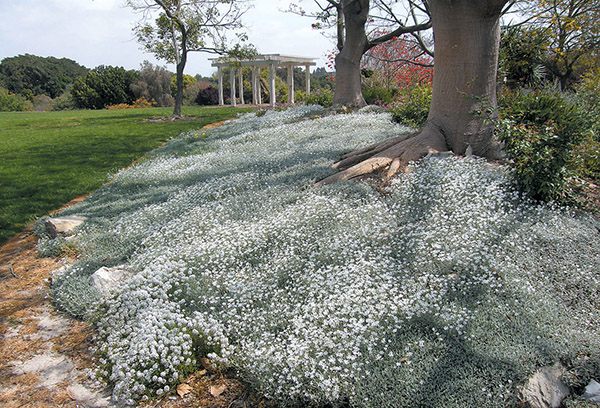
[0,107,251,243]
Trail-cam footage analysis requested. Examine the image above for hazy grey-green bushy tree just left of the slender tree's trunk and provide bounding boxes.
[131,61,175,106]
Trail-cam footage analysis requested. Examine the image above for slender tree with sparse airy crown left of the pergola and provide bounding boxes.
[127,0,249,117]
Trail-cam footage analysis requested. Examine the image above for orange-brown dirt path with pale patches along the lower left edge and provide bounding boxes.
[0,223,111,408]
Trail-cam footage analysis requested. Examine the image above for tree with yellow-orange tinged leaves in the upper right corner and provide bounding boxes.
[510,0,600,89]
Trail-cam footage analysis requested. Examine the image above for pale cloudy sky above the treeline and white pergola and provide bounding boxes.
[0,0,334,76]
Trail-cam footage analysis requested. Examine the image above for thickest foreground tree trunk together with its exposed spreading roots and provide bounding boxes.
[317,0,507,186]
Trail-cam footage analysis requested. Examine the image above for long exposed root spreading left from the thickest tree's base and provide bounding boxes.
[314,124,448,187]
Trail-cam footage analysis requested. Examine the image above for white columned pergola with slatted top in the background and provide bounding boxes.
[210,54,317,106]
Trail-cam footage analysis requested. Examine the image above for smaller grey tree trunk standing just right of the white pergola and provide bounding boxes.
[333,0,369,108]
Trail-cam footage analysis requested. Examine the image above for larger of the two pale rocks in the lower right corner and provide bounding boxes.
[522,363,571,408]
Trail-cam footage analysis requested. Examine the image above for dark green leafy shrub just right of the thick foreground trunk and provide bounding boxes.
[496,90,592,201]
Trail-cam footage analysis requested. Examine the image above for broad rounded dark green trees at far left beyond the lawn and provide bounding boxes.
[0,54,88,98]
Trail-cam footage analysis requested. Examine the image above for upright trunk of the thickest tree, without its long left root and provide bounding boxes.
[428,0,506,158]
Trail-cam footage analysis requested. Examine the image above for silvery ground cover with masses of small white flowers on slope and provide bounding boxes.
[39,107,600,407]
